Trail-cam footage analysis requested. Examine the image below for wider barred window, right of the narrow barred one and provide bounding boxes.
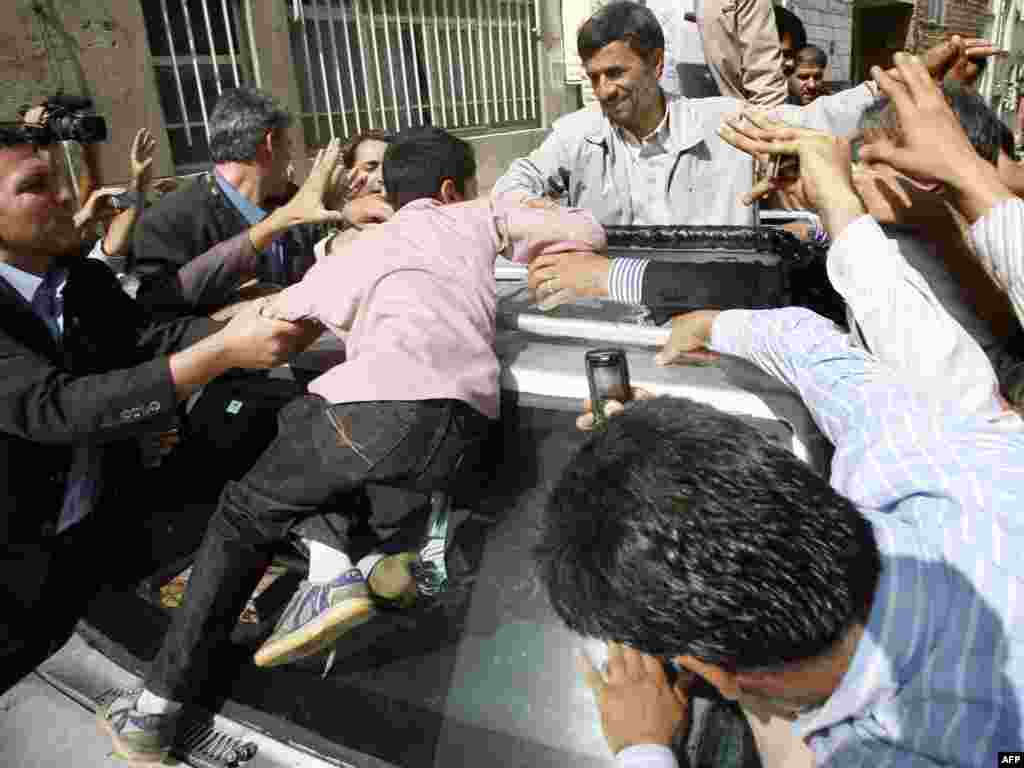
[286,0,540,146]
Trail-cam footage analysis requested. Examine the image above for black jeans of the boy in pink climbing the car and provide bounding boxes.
[146,395,488,701]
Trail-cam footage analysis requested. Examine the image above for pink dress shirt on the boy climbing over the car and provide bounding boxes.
[271,199,605,419]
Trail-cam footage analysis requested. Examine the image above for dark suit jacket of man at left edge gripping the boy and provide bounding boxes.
[0,252,220,663]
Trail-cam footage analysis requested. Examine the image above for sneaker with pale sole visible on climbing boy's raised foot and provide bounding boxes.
[255,568,374,667]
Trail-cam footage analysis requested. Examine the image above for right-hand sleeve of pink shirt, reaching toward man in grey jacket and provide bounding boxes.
[495,202,607,263]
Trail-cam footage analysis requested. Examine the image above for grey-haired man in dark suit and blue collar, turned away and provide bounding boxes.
[134,88,392,316]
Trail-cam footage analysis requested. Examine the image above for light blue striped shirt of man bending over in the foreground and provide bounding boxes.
[618,308,1024,768]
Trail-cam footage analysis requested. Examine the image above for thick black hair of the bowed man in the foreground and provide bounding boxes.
[536,397,881,670]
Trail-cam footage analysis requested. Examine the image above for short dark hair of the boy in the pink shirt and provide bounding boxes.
[383,126,476,210]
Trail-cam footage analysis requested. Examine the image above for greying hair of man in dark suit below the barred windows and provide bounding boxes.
[210,88,292,163]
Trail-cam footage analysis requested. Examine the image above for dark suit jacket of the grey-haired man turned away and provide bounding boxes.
[132,171,323,316]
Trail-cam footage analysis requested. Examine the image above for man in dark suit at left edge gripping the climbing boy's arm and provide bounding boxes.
[0,124,338,691]
